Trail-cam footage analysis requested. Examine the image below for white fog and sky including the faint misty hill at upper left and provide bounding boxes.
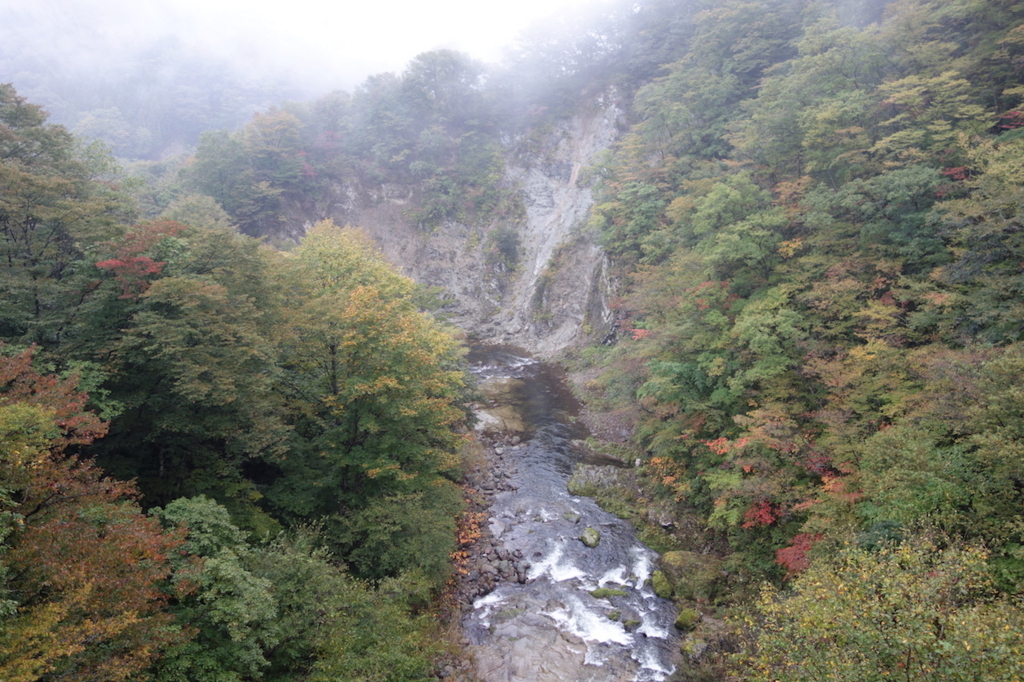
[0,0,603,158]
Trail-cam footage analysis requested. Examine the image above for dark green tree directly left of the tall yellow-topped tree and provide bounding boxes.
[93,219,287,527]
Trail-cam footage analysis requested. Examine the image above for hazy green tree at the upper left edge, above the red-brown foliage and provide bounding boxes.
[0,85,127,347]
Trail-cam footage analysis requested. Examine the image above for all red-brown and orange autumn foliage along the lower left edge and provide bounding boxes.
[0,349,185,681]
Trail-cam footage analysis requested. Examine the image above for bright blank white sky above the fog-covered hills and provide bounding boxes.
[0,0,602,89]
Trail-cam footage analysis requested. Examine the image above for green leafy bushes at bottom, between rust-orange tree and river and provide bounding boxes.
[153,497,438,682]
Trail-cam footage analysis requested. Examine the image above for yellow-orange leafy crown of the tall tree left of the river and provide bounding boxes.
[282,221,465,503]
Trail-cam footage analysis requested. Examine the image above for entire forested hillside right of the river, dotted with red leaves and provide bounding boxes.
[580,0,1024,680]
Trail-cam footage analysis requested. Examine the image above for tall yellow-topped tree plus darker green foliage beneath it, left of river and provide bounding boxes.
[267,222,465,578]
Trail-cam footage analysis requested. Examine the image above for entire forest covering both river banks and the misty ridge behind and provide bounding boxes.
[6,0,1024,682]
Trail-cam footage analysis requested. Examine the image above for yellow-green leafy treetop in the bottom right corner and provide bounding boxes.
[734,541,1024,682]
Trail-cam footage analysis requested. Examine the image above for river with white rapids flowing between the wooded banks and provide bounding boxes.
[463,347,678,682]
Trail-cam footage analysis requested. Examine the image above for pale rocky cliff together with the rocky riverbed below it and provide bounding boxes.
[288,93,678,682]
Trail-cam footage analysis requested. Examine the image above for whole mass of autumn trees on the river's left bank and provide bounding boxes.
[0,79,467,681]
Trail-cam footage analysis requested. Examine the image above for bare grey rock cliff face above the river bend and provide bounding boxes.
[299,93,622,356]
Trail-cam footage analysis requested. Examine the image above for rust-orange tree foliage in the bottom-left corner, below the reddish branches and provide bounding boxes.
[0,461,186,680]
